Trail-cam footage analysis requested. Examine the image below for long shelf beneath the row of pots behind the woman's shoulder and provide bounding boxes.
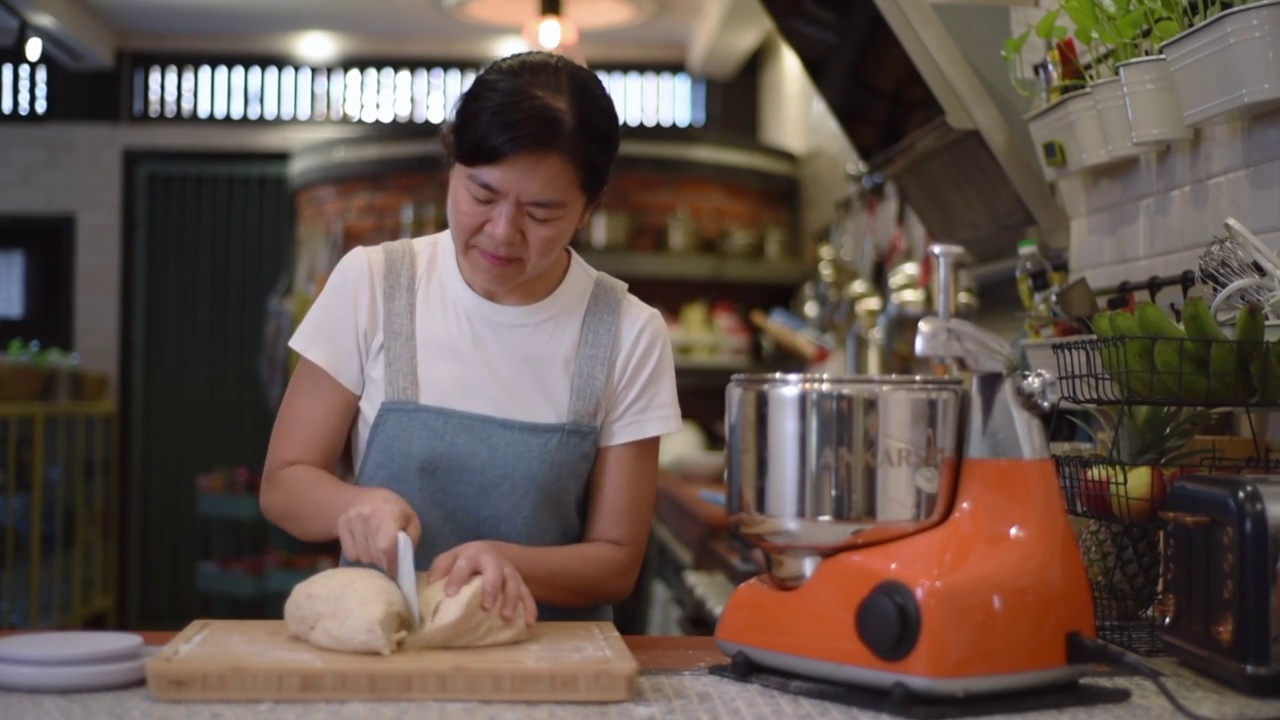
[579,250,809,286]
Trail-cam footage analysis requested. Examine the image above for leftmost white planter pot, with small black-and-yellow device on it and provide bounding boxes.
[1024,88,1111,182]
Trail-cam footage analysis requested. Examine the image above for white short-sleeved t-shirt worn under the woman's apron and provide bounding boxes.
[289,231,681,468]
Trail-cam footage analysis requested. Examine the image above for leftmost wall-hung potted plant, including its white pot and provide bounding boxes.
[1001,8,1111,182]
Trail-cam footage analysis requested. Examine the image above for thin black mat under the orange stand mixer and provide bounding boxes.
[709,652,1133,720]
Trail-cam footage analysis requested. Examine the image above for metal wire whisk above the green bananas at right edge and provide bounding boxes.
[1196,218,1280,318]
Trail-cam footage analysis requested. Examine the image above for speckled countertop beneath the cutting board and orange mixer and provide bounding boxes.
[0,633,1280,720]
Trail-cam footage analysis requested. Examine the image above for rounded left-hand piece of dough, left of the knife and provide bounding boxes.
[284,568,408,655]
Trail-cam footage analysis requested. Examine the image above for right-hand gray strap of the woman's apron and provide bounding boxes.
[568,273,627,425]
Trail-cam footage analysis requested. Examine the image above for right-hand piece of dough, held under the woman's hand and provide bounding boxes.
[402,574,531,650]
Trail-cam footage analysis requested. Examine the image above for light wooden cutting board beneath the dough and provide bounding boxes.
[146,620,640,702]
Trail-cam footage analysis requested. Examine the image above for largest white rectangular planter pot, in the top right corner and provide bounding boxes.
[1160,0,1280,127]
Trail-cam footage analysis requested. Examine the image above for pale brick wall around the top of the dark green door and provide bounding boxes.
[0,123,363,387]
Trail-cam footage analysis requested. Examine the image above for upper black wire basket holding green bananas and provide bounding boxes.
[1053,336,1280,407]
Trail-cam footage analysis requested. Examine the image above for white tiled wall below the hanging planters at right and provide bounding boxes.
[1060,113,1280,294]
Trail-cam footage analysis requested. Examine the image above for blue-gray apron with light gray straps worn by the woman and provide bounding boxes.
[343,240,626,621]
